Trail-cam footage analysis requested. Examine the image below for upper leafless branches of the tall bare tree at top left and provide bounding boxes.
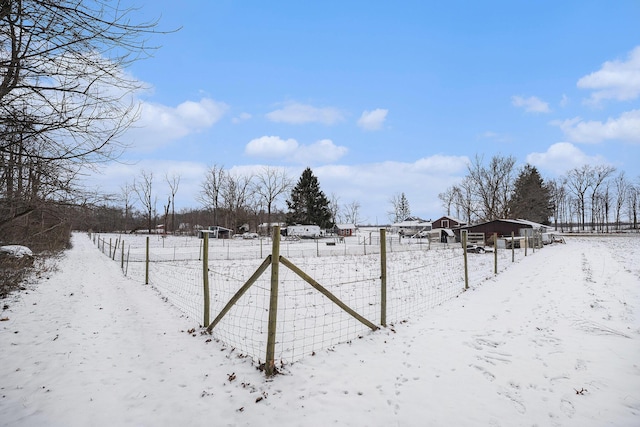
[0,0,162,161]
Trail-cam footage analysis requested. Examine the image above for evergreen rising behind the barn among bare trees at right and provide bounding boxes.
[509,164,553,225]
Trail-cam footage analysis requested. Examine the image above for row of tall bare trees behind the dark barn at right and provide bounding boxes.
[439,155,640,231]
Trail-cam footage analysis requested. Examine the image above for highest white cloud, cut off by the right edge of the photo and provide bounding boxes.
[577,46,640,105]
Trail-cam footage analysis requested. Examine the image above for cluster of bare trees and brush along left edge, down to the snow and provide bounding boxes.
[0,0,162,249]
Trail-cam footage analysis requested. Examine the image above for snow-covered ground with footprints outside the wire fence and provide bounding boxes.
[0,234,640,427]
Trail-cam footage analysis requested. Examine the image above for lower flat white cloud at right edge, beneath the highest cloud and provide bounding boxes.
[551,110,640,144]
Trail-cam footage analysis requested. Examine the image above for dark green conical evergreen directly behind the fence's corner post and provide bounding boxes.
[287,168,332,228]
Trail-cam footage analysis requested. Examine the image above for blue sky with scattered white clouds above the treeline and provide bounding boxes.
[87,0,640,223]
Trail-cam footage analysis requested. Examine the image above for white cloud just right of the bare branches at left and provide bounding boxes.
[126,98,228,151]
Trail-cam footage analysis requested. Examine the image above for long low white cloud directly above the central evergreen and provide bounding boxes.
[245,136,348,164]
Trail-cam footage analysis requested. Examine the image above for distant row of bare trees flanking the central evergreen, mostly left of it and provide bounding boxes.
[84,164,370,236]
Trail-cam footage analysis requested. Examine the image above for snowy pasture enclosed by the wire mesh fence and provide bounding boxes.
[93,230,548,376]
